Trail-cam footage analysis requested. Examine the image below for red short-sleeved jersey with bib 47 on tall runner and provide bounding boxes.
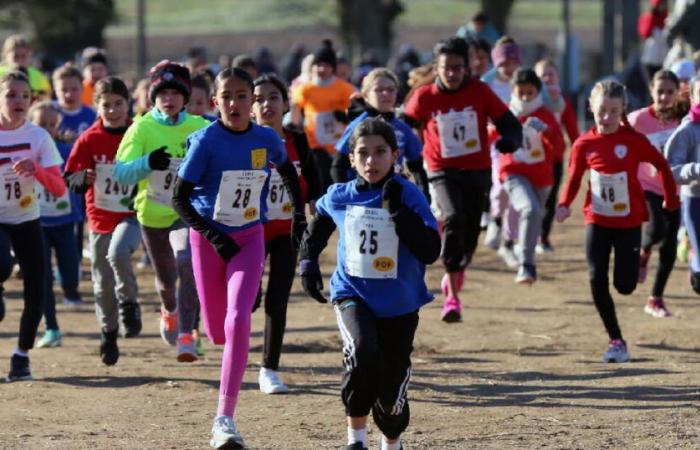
[405,79,508,172]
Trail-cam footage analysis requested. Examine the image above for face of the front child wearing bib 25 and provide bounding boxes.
[350,134,398,183]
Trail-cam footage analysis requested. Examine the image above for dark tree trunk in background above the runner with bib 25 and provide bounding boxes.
[338,0,404,61]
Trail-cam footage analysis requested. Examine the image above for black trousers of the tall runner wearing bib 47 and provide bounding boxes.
[428,170,491,273]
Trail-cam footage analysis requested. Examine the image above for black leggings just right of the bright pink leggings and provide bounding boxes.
[255,234,297,370]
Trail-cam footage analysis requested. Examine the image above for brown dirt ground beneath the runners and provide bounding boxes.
[0,202,700,449]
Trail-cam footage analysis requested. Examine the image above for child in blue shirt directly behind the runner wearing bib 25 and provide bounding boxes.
[331,67,430,199]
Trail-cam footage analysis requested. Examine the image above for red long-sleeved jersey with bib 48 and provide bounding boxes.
[559,126,679,228]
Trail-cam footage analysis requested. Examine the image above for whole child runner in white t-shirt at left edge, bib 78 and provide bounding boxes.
[0,72,66,381]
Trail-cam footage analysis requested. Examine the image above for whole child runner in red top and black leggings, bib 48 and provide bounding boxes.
[556,81,679,362]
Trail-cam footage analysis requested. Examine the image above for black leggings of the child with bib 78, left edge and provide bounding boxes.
[0,219,47,351]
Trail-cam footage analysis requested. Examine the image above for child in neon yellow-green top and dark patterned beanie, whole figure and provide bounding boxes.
[114,61,209,362]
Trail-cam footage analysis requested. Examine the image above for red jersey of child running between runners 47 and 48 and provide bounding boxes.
[499,106,565,188]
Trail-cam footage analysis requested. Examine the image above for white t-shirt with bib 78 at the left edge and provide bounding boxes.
[0,121,63,225]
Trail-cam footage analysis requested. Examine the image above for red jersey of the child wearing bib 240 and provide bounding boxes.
[65,119,135,234]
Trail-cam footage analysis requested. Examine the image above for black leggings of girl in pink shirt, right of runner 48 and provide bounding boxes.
[642,191,681,297]
